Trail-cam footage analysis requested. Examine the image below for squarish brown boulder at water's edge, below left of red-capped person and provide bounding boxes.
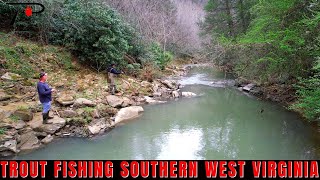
[18,131,41,151]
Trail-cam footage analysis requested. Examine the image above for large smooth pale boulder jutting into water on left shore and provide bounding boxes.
[114,106,144,124]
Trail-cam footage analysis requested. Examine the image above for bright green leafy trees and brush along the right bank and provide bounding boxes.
[202,0,320,120]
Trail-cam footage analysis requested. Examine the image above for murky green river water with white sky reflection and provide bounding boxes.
[14,67,319,160]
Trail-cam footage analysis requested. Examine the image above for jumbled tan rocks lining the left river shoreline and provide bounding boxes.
[0,67,196,157]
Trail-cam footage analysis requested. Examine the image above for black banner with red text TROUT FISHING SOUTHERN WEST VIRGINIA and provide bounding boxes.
[0,160,319,179]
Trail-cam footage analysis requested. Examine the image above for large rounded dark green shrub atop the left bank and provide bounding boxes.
[51,0,133,71]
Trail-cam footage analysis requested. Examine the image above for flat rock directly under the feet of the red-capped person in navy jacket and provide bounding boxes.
[34,116,66,134]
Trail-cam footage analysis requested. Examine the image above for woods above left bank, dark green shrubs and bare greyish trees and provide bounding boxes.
[0,0,204,76]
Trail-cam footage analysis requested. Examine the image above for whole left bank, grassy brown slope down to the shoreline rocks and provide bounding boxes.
[0,34,192,156]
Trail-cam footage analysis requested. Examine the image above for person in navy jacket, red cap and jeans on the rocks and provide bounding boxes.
[37,70,56,124]
